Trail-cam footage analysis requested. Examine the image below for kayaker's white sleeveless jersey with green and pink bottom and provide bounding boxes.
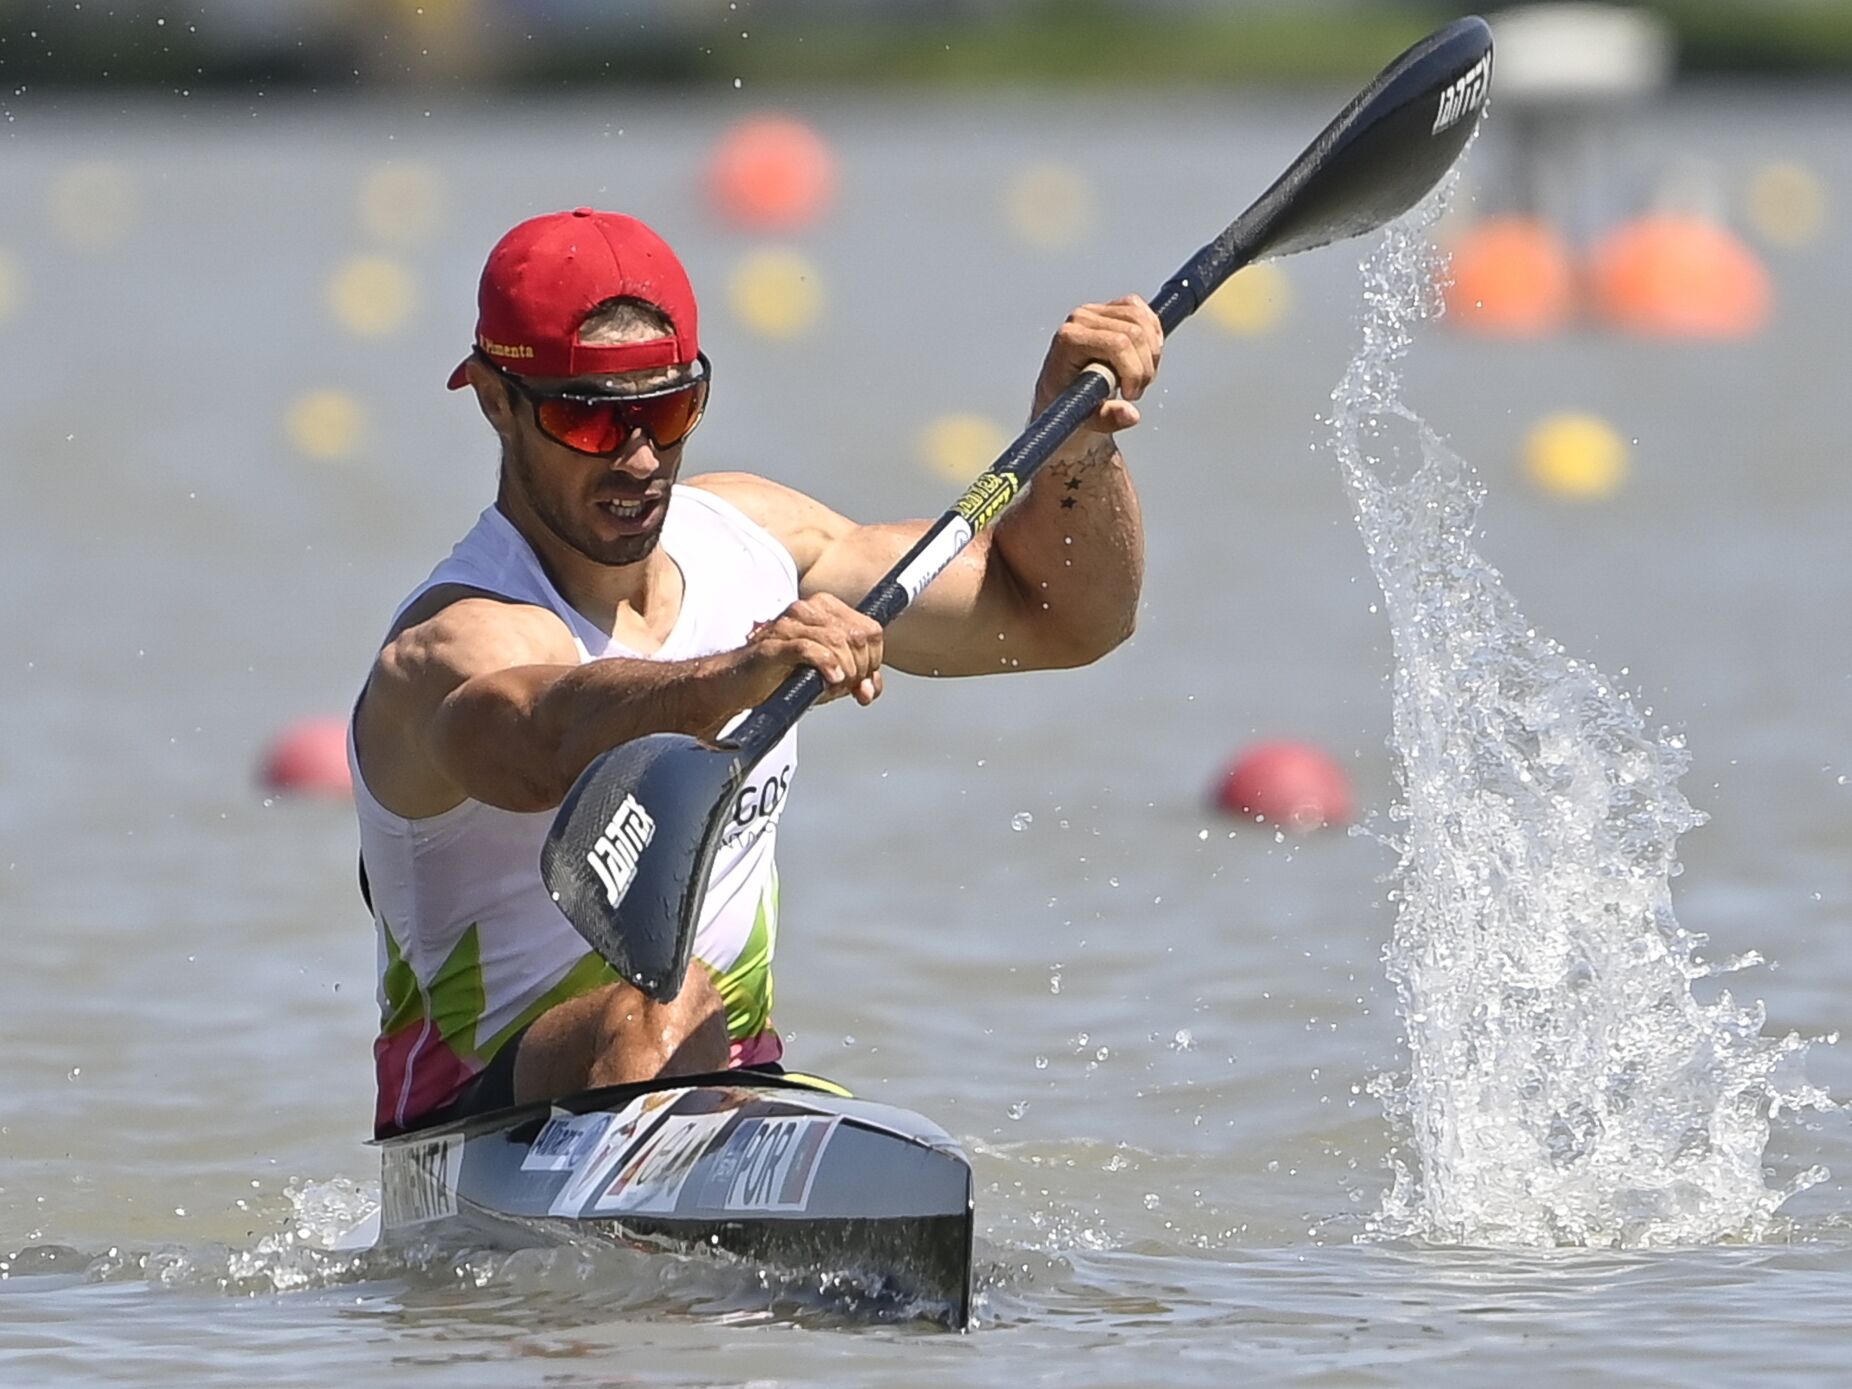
[348,487,798,1132]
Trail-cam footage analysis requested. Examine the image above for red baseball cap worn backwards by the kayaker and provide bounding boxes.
[450,207,700,391]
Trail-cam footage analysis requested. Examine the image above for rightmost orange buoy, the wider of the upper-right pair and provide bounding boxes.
[1589,213,1772,339]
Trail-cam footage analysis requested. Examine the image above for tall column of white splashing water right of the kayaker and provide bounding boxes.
[1332,193,1830,1246]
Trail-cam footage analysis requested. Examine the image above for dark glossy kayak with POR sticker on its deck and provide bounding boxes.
[364,1070,972,1330]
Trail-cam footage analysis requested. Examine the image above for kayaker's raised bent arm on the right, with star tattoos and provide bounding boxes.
[691,298,1163,676]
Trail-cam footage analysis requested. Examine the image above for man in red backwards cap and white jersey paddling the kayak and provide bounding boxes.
[350,207,1163,1135]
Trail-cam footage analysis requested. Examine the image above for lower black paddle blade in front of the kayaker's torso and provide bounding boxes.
[541,733,748,1002]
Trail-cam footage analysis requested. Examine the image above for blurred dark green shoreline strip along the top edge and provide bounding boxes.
[4,0,1852,91]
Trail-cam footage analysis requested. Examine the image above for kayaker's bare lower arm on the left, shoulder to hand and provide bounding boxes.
[354,589,880,819]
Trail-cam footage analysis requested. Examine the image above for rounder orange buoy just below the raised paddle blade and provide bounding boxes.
[1446,213,1576,337]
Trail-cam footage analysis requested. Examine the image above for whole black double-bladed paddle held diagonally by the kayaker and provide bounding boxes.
[541,17,1493,1000]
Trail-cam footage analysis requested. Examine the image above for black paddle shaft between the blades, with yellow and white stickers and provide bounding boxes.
[728,268,1222,763]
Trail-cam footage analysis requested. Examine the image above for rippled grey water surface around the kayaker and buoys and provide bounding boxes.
[0,91,1852,1387]
